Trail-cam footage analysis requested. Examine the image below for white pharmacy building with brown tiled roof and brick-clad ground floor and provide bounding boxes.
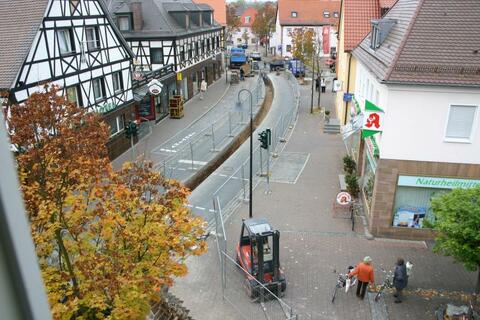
[346,0,480,239]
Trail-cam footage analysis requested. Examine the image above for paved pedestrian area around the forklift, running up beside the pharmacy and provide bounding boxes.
[172,74,476,320]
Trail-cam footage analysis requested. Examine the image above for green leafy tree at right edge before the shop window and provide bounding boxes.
[427,186,480,296]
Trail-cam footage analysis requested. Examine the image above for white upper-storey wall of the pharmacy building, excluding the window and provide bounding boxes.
[355,62,480,164]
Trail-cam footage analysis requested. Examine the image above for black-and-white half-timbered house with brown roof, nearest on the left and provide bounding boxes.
[0,0,138,158]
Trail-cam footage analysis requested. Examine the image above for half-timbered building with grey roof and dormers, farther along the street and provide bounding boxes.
[109,0,223,120]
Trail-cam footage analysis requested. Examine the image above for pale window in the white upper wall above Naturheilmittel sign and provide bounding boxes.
[445,105,478,142]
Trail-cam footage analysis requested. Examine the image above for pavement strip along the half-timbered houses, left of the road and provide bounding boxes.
[112,75,233,169]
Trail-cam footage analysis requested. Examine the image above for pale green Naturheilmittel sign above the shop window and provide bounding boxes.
[398,176,480,189]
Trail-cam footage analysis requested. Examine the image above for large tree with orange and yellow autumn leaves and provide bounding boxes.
[7,86,205,319]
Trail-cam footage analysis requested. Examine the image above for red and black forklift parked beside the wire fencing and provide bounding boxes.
[236,218,287,299]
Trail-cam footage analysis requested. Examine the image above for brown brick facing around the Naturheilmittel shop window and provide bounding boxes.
[369,159,480,240]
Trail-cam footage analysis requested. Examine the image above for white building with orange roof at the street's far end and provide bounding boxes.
[270,0,341,57]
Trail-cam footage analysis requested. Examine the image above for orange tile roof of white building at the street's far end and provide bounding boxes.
[278,0,341,26]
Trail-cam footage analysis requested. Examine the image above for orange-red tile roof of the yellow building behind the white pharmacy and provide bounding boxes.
[343,0,380,51]
